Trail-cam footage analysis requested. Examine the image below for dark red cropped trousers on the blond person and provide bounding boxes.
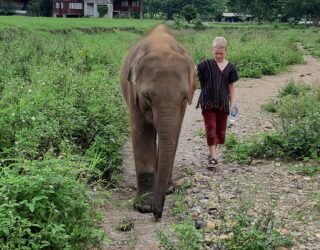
[202,109,228,146]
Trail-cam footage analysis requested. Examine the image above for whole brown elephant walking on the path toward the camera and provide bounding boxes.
[120,24,196,220]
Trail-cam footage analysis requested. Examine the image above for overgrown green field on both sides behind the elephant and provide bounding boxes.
[0,17,320,249]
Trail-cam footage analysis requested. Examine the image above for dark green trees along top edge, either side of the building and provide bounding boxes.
[0,0,320,25]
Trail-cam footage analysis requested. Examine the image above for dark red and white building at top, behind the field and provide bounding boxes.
[53,0,141,18]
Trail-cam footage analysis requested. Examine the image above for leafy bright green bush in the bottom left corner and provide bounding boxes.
[0,158,106,250]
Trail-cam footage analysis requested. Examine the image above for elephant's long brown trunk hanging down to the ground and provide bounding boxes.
[152,109,184,219]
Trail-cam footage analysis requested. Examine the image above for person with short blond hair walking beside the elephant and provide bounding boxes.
[197,37,239,168]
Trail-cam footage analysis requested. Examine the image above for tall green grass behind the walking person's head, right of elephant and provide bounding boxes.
[179,27,303,77]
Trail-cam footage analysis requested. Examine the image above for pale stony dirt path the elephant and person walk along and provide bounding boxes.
[102,56,320,250]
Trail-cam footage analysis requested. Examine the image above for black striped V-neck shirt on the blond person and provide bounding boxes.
[197,59,239,114]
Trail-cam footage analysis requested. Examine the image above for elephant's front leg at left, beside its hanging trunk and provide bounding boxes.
[131,111,157,213]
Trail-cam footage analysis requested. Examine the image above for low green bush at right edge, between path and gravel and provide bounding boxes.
[225,83,320,164]
